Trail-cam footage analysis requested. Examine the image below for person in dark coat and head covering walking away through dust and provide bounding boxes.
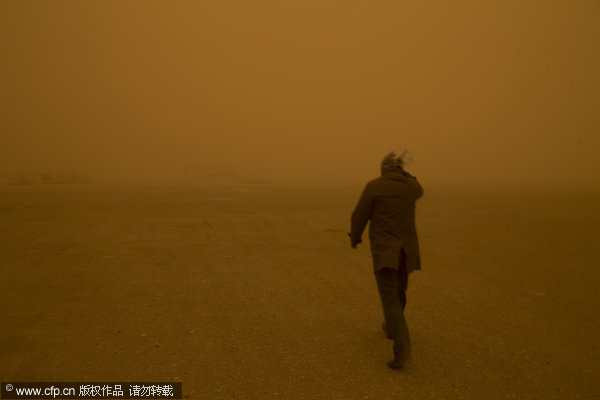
[348,150,423,369]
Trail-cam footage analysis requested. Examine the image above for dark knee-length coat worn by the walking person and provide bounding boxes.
[350,168,423,272]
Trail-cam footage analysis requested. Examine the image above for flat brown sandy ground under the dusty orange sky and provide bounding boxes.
[0,185,600,399]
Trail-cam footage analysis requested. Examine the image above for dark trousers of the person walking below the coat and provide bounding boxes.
[375,250,410,353]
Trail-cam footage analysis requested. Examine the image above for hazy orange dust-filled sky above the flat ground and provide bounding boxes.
[0,0,600,188]
